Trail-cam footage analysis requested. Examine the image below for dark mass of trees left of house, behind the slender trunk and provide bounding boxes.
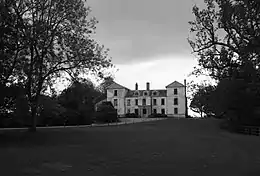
[0,79,107,128]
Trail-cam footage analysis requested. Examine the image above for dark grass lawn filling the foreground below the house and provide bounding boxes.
[0,119,260,176]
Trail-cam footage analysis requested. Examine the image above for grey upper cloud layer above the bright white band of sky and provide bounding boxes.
[88,0,198,64]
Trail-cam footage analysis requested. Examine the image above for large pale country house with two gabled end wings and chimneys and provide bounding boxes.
[106,80,187,117]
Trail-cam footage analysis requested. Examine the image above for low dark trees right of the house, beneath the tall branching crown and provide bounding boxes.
[190,79,260,126]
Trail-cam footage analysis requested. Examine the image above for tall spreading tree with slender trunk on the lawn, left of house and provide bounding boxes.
[1,0,112,131]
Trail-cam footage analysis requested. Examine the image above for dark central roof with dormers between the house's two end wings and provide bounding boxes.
[126,90,167,98]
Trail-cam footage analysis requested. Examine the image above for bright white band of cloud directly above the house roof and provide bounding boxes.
[115,55,197,89]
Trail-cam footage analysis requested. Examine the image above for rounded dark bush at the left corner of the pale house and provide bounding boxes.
[95,102,119,123]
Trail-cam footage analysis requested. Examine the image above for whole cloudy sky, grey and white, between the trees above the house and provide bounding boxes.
[87,0,206,89]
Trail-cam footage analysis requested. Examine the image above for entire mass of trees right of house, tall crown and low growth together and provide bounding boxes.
[189,0,260,129]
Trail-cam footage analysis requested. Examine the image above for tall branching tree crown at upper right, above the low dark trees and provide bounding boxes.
[188,0,260,80]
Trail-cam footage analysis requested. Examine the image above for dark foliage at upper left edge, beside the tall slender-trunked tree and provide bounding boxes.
[0,0,26,86]
